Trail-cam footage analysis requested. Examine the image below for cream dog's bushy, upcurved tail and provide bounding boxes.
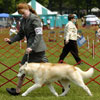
[75,67,94,79]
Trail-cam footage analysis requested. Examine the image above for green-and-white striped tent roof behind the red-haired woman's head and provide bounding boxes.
[12,0,57,16]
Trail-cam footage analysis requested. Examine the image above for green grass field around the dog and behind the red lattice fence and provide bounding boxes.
[0,19,100,100]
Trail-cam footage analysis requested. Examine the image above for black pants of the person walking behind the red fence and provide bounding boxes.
[59,40,81,63]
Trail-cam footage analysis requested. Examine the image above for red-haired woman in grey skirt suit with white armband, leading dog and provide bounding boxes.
[4,3,48,95]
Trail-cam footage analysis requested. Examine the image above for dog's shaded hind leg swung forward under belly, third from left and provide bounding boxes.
[59,80,70,96]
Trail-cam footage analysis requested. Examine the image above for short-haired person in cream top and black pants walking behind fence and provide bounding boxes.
[59,14,82,64]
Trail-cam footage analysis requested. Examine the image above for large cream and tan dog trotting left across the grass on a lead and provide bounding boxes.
[17,62,94,96]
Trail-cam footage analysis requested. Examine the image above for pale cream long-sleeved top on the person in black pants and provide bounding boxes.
[64,21,79,41]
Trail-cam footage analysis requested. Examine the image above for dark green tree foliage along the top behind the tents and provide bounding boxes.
[0,0,100,14]
